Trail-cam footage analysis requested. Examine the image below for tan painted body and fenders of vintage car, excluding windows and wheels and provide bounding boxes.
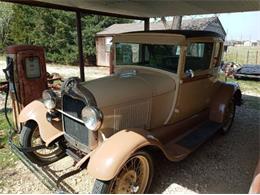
[19,30,242,180]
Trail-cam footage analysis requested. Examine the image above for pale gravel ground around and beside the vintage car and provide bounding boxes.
[0,60,260,194]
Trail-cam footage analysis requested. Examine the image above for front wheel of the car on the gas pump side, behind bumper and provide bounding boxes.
[20,121,65,166]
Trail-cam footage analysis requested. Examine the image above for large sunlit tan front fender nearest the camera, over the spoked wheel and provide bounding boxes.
[87,129,162,181]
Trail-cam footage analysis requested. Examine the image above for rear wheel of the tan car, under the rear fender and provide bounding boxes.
[221,98,236,134]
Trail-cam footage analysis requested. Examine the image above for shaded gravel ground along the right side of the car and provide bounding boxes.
[151,95,260,194]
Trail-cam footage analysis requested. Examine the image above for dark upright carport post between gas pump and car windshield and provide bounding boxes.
[76,11,85,81]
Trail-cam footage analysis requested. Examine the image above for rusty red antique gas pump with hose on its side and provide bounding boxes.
[4,45,47,131]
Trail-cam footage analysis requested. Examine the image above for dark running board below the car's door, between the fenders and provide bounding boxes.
[164,121,221,161]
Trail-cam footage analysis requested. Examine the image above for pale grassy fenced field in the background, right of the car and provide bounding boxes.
[224,46,260,64]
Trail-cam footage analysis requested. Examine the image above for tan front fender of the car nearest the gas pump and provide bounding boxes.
[18,100,63,146]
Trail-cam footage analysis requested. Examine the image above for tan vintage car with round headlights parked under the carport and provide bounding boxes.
[19,30,241,193]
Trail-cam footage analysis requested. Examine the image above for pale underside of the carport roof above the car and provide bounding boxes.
[4,0,260,19]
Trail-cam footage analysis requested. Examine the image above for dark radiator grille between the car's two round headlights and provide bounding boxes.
[63,95,88,145]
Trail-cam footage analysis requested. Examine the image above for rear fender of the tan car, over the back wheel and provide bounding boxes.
[209,82,242,123]
